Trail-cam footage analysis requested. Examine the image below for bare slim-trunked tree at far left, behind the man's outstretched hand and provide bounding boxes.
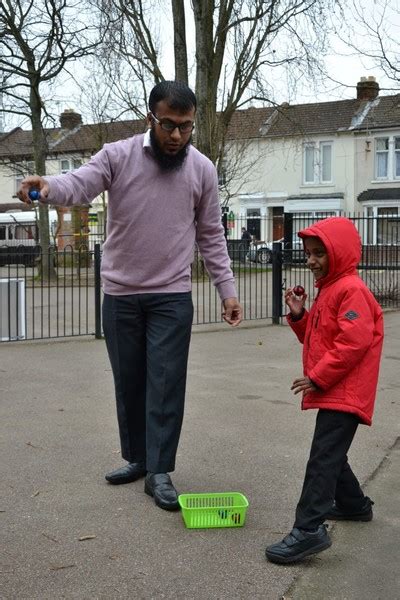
[0,0,97,277]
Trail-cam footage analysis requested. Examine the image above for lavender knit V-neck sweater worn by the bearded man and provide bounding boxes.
[46,134,236,300]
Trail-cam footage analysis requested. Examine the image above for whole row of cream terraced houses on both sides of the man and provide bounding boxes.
[0,77,400,243]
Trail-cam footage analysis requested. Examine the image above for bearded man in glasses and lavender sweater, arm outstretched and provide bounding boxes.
[18,81,242,510]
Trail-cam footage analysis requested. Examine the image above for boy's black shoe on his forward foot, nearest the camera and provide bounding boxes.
[265,525,332,564]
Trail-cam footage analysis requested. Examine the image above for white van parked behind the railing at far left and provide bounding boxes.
[0,210,57,266]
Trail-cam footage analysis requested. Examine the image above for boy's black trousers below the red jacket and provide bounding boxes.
[294,409,364,530]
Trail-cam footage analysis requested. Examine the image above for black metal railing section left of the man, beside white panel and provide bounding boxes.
[0,247,95,341]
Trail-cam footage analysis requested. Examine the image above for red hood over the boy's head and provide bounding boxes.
[298,217,361,287]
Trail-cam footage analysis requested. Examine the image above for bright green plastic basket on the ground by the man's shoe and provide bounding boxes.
[178,492,249,529]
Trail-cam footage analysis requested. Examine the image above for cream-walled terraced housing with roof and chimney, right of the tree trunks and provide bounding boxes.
[223,77,400,243]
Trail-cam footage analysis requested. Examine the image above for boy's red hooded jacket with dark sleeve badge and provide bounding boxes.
[287,217,383,425]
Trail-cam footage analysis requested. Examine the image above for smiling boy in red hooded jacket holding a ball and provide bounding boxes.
[266,217,383,564]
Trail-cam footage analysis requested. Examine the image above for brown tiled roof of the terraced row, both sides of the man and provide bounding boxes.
[0,94,400,160]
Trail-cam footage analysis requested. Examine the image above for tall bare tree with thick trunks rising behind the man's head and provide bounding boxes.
[91,0,335,193]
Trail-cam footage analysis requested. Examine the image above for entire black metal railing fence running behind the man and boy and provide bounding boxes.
[0,215,400,341]
